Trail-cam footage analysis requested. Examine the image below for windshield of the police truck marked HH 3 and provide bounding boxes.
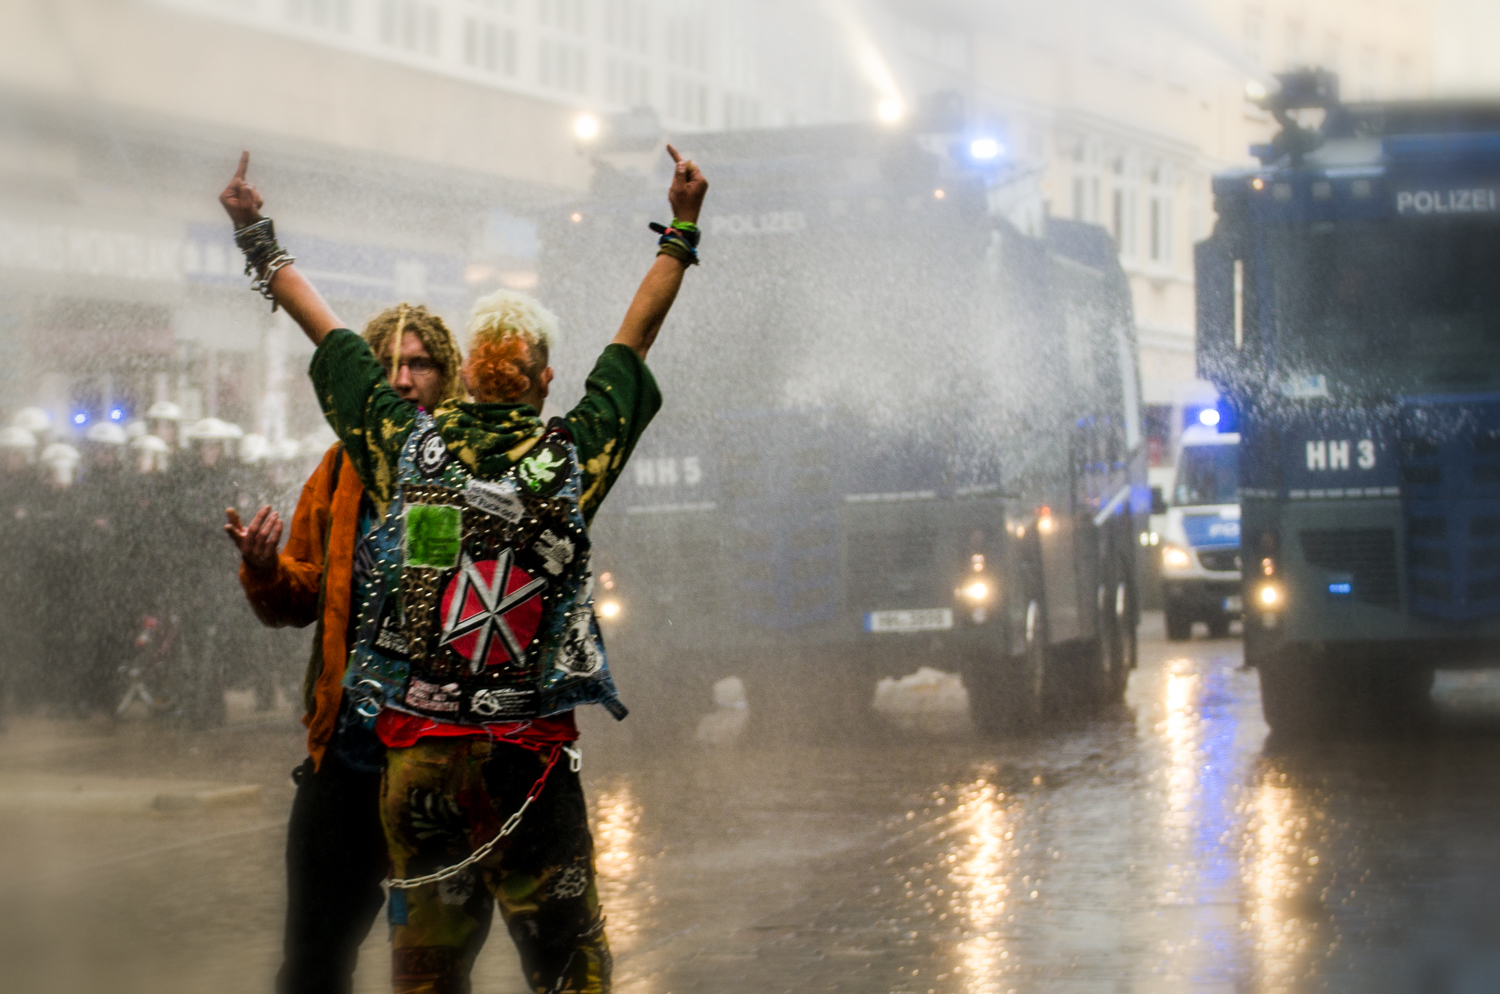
[1268,219,1500,396]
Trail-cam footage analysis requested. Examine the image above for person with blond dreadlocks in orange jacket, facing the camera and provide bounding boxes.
[225,303,464,994]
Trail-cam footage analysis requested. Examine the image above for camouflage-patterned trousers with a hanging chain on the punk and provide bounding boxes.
[381,738,612,994]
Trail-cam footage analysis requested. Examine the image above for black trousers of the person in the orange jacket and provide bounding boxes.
[276,751,389,994]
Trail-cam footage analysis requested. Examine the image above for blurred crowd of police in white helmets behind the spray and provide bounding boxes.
[0,402,333,726]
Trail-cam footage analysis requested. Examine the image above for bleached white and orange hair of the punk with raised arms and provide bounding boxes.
[464,289,558,403]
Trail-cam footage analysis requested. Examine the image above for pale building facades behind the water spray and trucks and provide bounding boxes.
[0,0,1473,446]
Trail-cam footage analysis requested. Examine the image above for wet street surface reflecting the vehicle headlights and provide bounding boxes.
[0,618,1500,994]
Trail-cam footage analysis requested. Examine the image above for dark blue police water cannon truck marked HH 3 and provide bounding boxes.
[1197,70,1500,735]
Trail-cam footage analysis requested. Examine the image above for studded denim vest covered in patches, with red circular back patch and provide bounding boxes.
[344,414,626,724]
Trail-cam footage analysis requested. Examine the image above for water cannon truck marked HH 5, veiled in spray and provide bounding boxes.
[540,116,1149,733]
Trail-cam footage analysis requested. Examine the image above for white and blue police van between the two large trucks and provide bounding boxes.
[1161,427,1241,642]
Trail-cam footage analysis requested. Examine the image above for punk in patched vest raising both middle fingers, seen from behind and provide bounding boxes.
[221,145,708,994]
